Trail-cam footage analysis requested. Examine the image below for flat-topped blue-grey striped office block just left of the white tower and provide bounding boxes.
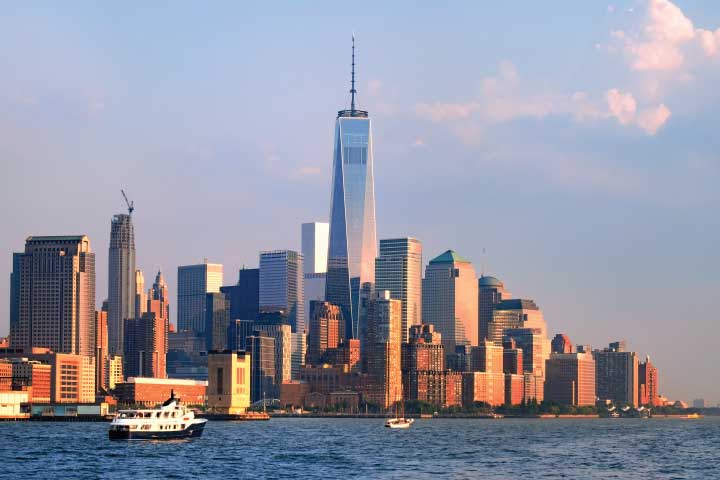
[260,250,305,333]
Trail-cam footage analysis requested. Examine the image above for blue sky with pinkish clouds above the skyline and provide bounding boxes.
[0,0,720,404]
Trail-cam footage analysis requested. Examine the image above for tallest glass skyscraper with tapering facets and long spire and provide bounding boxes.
[325,36,377,338]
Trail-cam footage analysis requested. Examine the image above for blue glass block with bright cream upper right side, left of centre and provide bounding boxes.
[177,260,223,337]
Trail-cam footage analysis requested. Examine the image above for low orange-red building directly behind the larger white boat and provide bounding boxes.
[115,377,208,407]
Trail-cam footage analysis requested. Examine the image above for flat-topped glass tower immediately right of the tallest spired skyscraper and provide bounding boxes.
[375,237,422,342]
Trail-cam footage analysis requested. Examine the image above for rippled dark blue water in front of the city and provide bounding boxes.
[0,417,720,479]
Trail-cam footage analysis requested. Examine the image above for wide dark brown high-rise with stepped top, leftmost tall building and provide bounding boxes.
[10,235,96,356]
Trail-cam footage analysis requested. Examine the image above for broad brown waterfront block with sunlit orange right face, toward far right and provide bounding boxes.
[544,352,596,406]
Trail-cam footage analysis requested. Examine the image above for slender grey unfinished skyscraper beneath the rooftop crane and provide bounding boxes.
[108,214,136,355]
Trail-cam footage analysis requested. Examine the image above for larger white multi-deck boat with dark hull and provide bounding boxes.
[108,392,207,440]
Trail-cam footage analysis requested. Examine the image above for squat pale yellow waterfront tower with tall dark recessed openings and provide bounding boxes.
[207,350,251,415]
